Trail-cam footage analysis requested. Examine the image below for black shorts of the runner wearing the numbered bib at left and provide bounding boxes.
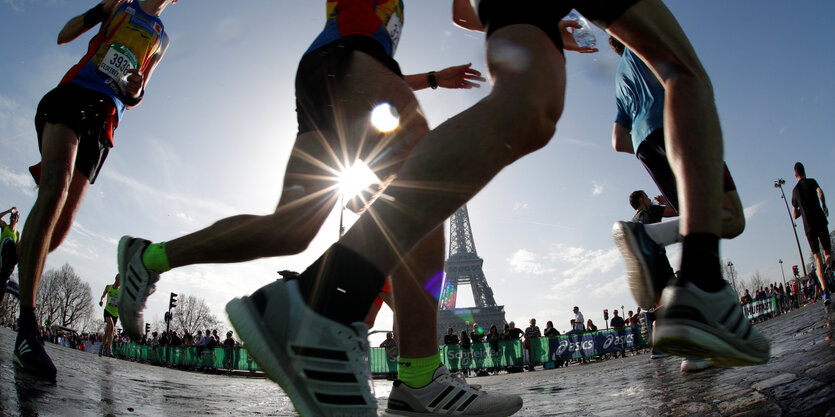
[34,83,118,184]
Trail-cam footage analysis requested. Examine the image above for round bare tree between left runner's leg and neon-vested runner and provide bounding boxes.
[37,263,93,328]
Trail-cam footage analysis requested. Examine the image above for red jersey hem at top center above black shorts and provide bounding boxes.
[306,0,403,57]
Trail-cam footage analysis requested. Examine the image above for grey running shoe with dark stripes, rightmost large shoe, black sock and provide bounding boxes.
[653,282,771,366]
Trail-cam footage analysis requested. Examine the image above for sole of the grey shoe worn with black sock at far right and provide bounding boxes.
[653,319,769,367]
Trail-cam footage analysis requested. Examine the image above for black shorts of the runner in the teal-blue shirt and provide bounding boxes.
[635,129,736,211]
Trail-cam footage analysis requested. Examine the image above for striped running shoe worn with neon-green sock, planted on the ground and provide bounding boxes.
[386,365,522,417]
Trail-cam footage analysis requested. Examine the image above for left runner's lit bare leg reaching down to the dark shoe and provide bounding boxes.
[18,123,83,307]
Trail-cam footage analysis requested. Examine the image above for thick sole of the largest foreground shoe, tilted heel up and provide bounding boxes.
[226,297,377,416]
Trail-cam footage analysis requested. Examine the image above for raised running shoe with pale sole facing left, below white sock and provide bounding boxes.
[612,222,670,310]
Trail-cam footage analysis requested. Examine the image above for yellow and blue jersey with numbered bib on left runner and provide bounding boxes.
[61,1,168,123]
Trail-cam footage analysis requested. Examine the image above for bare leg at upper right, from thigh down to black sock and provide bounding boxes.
[607,0,722,236]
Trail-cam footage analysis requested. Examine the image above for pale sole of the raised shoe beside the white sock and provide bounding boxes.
[612,222,657,310]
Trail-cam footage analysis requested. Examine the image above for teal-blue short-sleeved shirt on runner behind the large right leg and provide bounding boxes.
[615,48,664,151]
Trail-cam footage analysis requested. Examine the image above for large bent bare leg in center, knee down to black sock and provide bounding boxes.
[340,25,565,272]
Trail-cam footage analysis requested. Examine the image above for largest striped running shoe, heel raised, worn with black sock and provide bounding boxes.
[226,280,377,417]
